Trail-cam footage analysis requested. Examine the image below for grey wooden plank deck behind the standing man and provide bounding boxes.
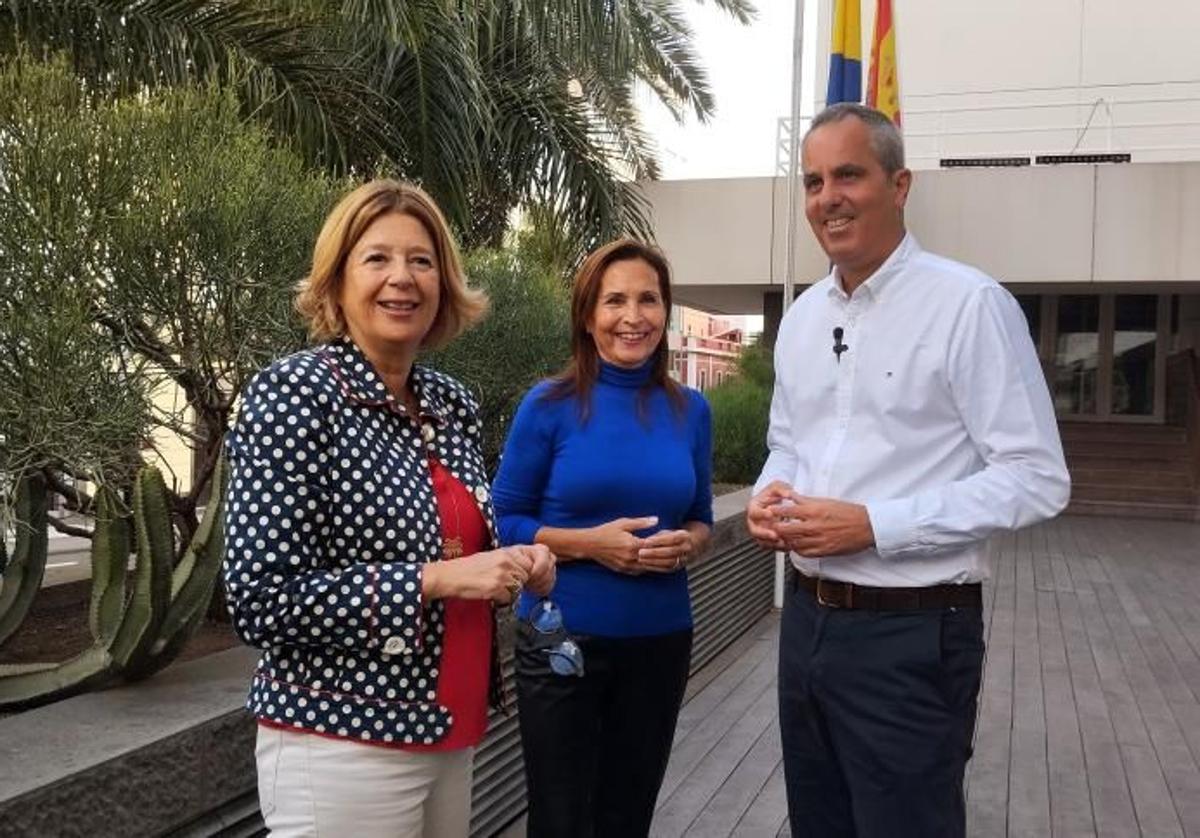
[652,516,1200,838]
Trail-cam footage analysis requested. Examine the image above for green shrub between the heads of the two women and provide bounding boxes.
[425,251,570,472]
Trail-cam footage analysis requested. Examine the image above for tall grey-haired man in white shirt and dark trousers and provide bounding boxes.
[746,104,1070,838]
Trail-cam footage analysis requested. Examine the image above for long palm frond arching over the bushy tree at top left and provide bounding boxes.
[0,0,395,171]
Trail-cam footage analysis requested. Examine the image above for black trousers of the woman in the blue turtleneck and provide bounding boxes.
[516,622,691,838]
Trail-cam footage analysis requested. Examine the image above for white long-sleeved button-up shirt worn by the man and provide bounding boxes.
[755,235,1070,587]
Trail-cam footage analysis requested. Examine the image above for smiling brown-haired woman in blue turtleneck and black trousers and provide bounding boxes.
[493,239,713,838]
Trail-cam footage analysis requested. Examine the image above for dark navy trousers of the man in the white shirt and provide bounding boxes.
[779,578,984,838]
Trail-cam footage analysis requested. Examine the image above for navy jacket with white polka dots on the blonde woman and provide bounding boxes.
[224,340,496,744]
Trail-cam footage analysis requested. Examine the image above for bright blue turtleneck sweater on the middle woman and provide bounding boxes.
[492,363,713,638]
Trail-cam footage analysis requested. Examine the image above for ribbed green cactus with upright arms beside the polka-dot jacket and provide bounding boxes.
[0,446,226,710]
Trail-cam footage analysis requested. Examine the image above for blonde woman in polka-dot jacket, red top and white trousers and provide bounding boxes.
[224,180,554,838]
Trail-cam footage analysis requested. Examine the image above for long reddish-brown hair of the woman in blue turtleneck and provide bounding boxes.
[546,239,685,421]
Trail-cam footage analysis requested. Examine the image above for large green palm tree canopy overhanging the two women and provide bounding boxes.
[0,0,754,258]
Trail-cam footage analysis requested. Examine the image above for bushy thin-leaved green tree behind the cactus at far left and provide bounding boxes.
[0,54,346,550]
